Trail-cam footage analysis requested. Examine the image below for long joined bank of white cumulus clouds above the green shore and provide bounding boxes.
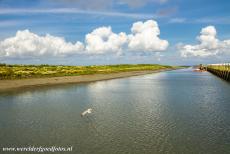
[0,20,169,58]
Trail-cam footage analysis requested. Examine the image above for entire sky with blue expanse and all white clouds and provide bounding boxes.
[0,0,230,65]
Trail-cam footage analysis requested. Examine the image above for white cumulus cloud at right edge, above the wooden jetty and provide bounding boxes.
[178,26,230,57]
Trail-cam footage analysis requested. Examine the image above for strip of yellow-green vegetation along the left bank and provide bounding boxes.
[0,64,174,80]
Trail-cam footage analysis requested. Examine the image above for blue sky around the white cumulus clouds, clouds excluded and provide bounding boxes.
[0,0,230,65]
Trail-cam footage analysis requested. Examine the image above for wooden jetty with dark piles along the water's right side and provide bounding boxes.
[207,63,230,81]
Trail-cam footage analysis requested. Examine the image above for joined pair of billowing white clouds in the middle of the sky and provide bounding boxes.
[86,20,169,54]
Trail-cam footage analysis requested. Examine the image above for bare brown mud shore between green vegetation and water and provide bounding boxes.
[0,68,175,92]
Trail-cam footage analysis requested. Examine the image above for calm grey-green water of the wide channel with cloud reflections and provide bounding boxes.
[0,69,230,154]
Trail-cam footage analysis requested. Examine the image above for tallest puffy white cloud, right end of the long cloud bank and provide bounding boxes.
[128,20,169,52]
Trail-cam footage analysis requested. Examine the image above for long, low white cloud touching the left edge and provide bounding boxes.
[0,30,84,57]
